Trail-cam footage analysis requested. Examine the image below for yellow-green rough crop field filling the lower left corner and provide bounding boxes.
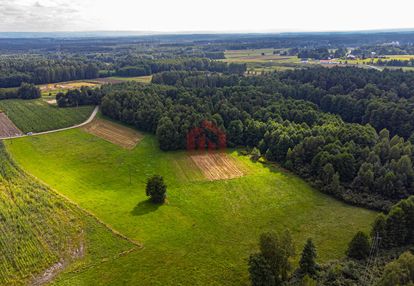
[0,143,134,285]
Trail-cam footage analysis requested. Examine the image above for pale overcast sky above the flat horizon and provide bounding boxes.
[0,0,414,32]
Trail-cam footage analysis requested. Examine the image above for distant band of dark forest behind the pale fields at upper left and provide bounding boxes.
[0,54,246,87]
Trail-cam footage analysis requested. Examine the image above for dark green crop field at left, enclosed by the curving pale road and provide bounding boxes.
[0,99,94,133]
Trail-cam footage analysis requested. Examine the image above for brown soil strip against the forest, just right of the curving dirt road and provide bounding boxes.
[83,119,143,149]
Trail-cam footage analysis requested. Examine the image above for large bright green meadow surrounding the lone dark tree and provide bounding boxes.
[6,129,375,285]
